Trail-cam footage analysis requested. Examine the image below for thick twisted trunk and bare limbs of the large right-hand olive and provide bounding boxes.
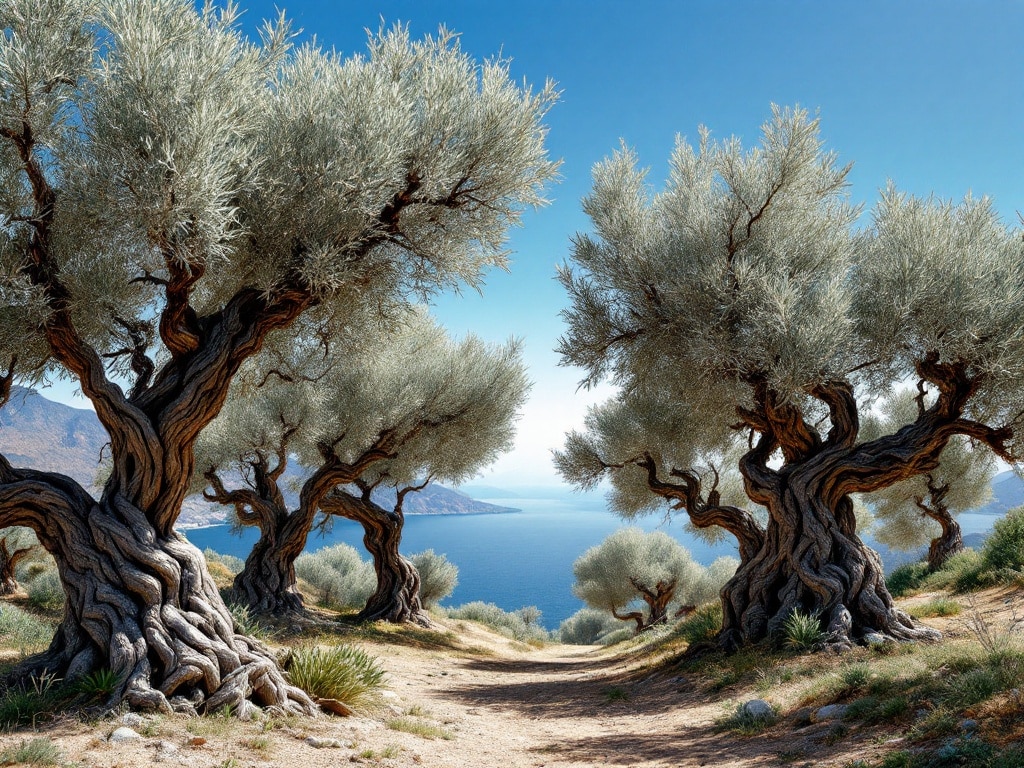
[719,370,1012,649]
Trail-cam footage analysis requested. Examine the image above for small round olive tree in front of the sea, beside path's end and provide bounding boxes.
[572,528,701,632]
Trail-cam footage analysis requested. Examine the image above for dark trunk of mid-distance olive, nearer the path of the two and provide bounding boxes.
[321,485,432,627]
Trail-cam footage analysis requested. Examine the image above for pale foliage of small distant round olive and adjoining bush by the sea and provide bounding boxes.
[572,527,738,612]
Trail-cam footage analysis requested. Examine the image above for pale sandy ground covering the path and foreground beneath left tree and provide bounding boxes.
[0,594,1020,768]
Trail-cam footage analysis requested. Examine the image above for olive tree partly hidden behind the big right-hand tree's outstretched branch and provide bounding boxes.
[861,389,995,570]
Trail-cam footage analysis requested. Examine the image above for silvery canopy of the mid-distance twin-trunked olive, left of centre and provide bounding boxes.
[197,308,529,499]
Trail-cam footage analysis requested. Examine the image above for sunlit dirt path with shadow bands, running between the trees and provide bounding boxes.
[366,626,880,768]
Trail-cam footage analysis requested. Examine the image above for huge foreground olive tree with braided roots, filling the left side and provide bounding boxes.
[0,0,555,716]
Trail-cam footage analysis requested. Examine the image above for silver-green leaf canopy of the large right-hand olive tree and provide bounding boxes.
[558,108,1024,528]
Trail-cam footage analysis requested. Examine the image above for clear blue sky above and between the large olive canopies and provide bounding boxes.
[49,0,1024,486]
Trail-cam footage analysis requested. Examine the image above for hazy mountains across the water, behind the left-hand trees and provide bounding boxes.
[0,387,518,528]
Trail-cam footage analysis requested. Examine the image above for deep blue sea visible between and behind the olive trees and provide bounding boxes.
[183,495,998,629]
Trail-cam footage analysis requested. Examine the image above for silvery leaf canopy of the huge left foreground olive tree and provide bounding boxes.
[0,0,557,385]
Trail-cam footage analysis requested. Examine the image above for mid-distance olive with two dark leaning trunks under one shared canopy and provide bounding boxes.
[197,310,527,624]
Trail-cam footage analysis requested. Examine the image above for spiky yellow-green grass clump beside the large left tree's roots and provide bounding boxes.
[286,645,384,707]
